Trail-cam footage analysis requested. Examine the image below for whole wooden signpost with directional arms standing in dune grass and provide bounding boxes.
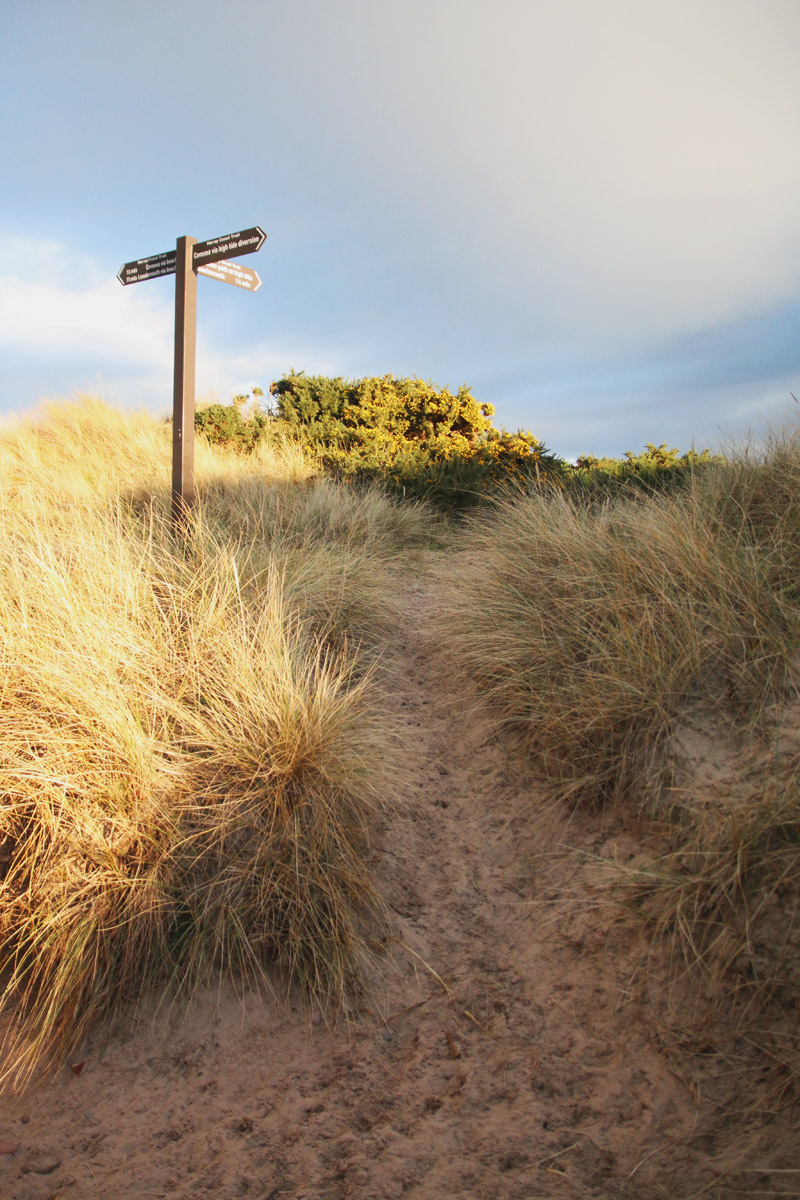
[116,226,266,530]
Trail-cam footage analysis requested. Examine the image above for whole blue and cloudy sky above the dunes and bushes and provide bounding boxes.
[0,0,800,457]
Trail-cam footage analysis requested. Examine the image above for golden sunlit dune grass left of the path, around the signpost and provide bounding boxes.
[0,400,429,1085]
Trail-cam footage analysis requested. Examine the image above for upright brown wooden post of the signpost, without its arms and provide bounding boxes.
[172,238,197,532]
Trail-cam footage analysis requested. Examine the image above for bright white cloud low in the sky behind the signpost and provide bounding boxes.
[0,236,350,410]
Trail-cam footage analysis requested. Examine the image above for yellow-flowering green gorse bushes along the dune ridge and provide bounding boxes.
[194,371,718,514]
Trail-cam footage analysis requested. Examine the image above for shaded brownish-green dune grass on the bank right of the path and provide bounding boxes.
[447,433,800,1070]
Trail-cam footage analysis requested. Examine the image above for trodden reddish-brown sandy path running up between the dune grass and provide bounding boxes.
[0,558,800,1200]
